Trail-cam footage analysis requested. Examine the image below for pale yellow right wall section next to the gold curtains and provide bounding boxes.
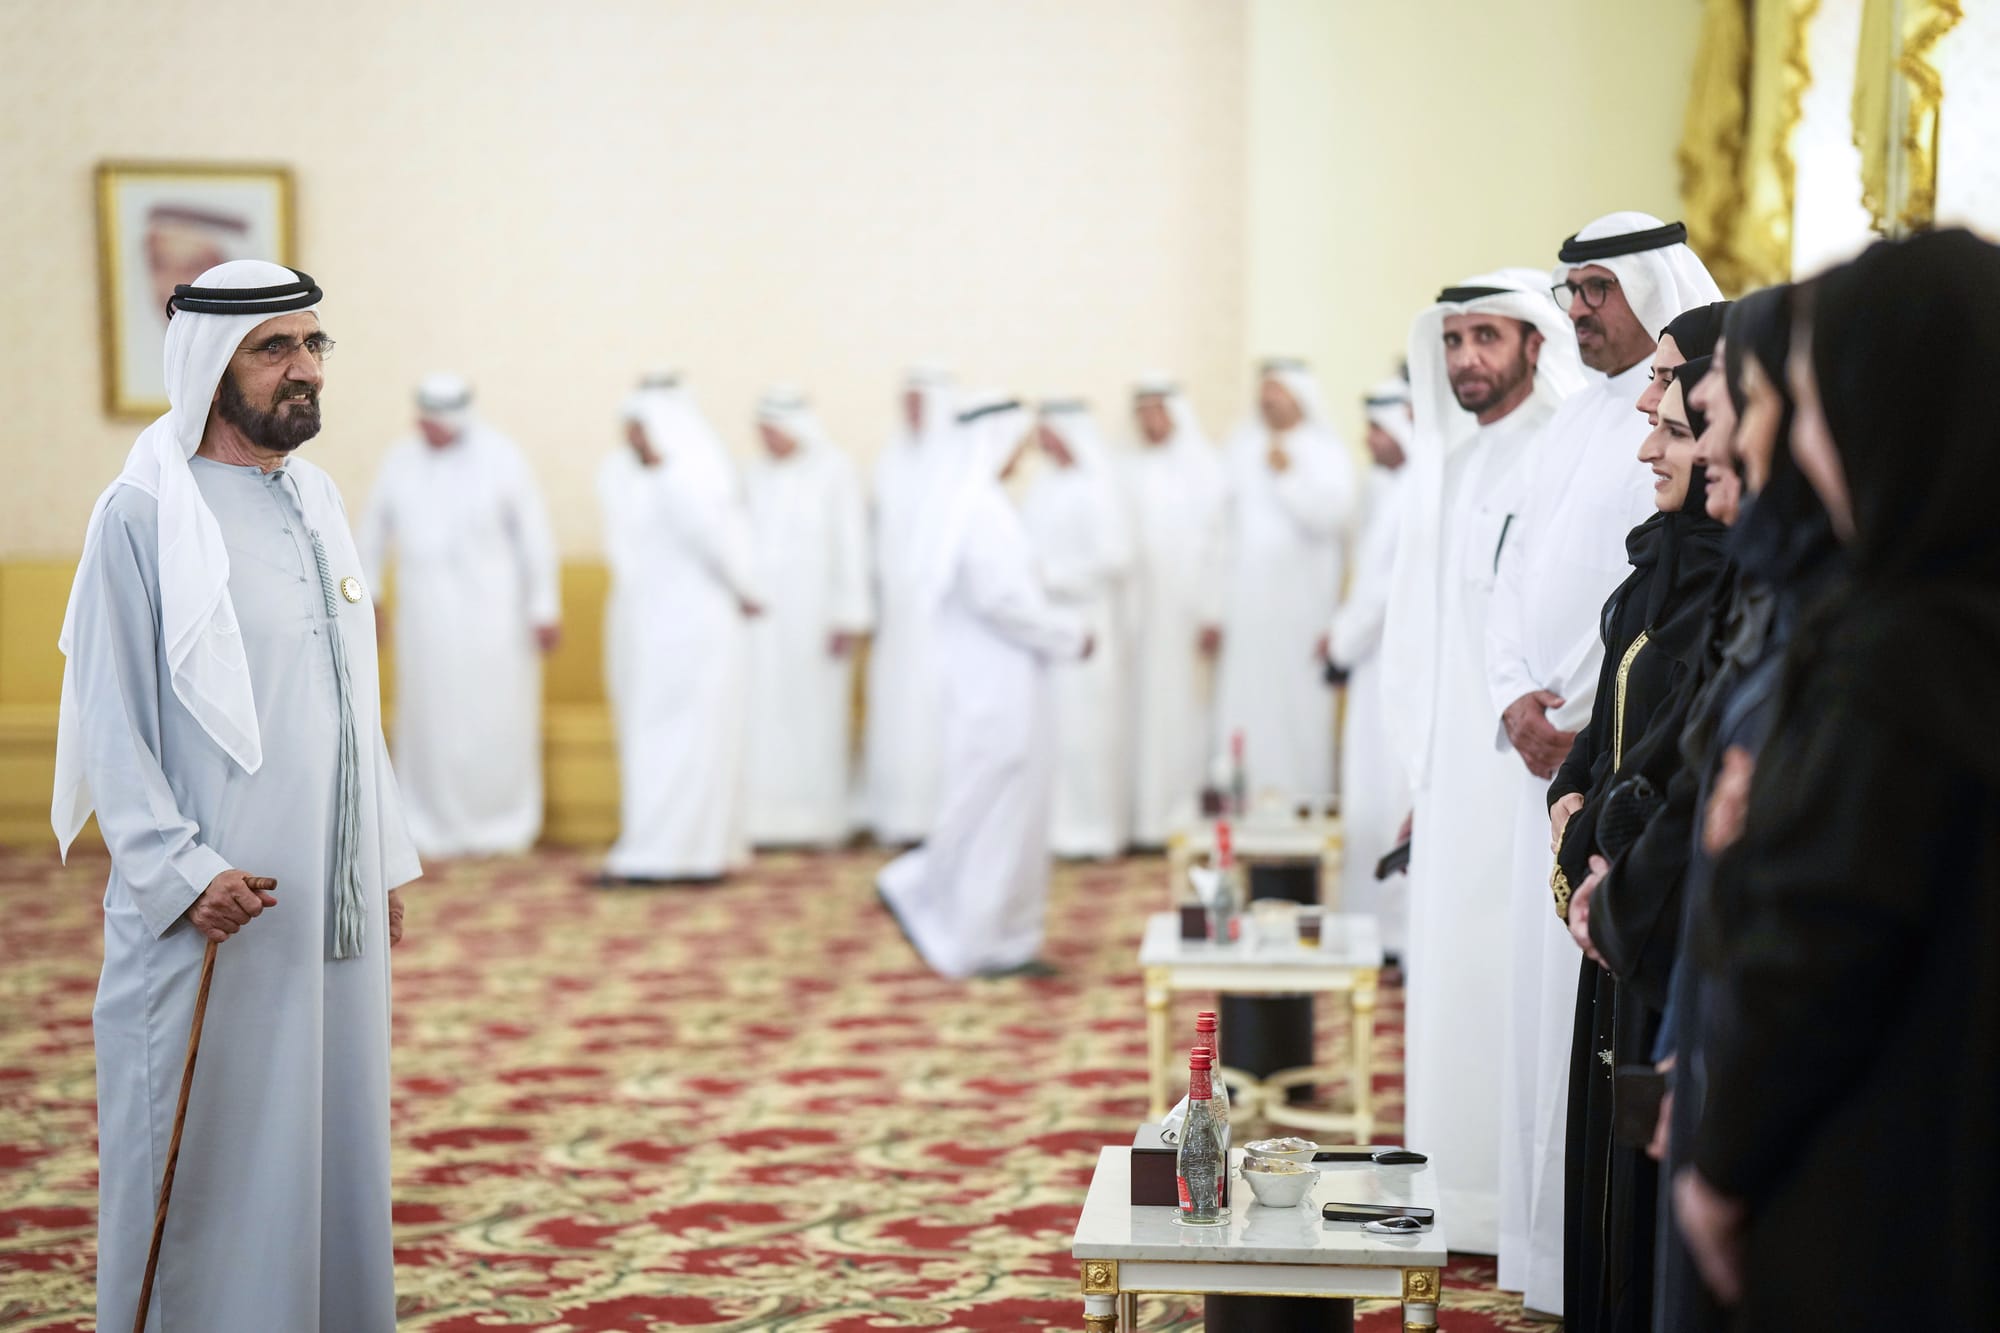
[1244,0,1700,430]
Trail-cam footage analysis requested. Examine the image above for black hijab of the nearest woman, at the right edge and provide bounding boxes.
[1812,230,2000,781]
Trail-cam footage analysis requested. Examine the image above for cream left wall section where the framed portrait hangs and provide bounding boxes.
[0,0,1246,554]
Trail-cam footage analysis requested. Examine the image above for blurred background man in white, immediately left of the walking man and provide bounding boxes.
[864,366,956,845]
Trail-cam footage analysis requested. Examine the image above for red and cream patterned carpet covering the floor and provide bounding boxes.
[0,853,1534,1333]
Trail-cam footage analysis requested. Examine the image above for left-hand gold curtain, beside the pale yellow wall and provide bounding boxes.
[1678,0,1820,292]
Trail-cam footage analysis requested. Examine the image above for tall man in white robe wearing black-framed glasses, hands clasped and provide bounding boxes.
[1488,212,1722,1315]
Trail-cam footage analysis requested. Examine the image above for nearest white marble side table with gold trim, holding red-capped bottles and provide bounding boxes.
[1070,1147,1446,1333]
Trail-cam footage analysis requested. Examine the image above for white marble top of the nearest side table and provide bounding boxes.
[1070,1147,1446,1269]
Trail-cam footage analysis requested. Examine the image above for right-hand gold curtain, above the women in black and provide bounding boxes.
[1854,0,1966,236]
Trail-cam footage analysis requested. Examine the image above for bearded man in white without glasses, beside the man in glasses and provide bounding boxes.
[1382,268,1582,1255]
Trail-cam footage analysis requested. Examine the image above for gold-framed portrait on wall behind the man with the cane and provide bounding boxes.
[98,162,296,416]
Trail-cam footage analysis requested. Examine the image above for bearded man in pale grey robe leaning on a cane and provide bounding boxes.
[52,260,418,1333]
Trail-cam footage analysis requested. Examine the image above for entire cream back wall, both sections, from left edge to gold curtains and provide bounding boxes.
[0,0,1696,554]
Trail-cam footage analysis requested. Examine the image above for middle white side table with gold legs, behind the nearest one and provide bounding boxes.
[1138,913,1382,1143]
